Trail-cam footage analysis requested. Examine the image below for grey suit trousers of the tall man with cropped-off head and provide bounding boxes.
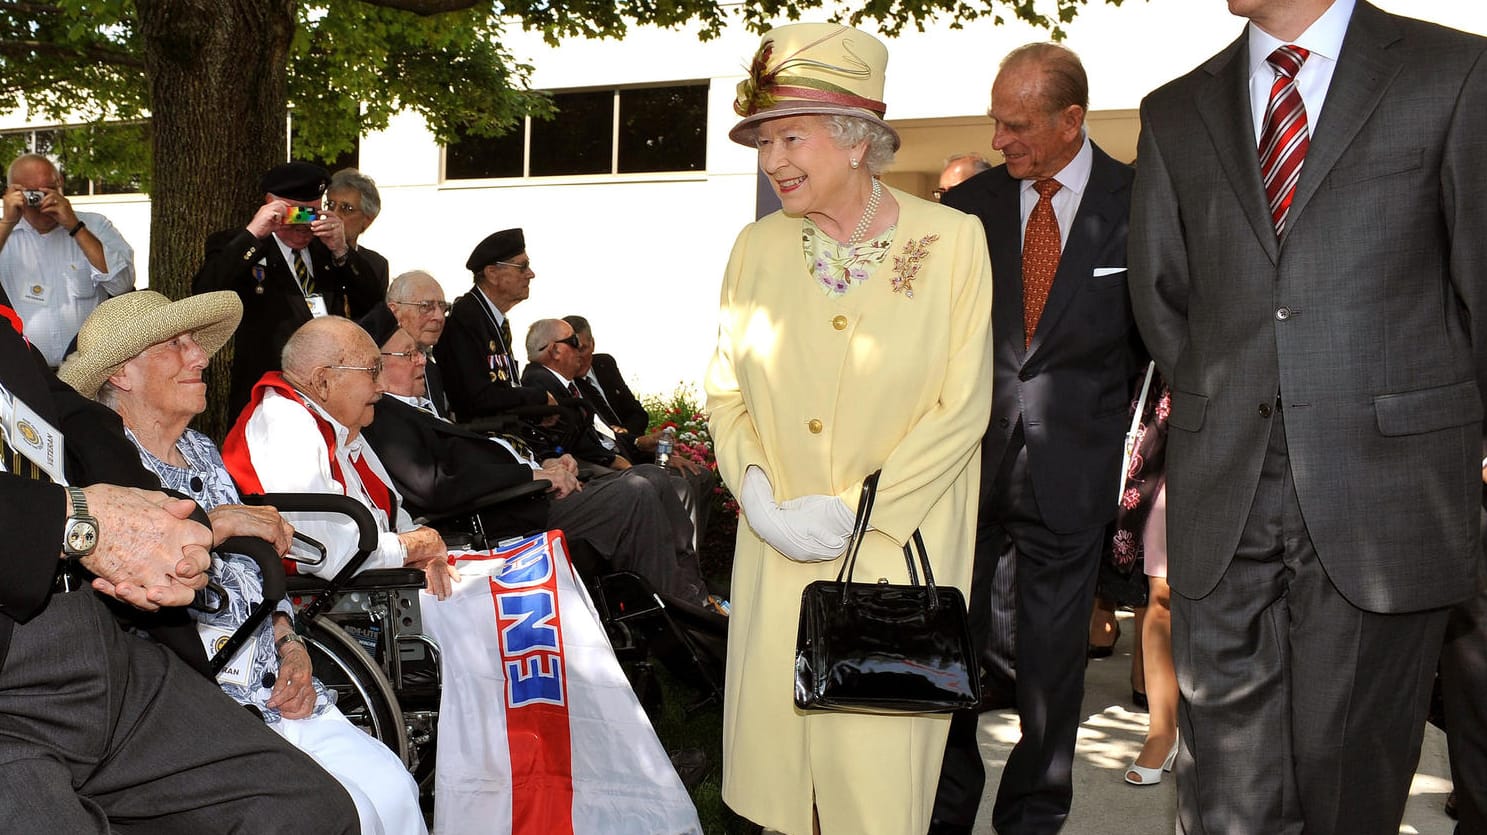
[1169,410,1447,835]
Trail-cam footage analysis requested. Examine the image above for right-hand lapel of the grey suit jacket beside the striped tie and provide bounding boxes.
[1286,3,1399,232]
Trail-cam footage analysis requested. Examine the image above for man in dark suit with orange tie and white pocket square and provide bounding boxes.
[931,43,1142,835]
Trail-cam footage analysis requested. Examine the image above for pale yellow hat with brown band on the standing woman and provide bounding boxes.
[729,24,898,150]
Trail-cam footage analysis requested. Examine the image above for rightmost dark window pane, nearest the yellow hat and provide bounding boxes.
[619,85,708,174]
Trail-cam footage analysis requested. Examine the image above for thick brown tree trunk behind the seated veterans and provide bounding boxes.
[138,0,294,441]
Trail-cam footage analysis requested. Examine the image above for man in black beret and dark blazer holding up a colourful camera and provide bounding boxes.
[192,162,384,416]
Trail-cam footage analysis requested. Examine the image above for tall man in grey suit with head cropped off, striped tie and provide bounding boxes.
[1130,0,1487,835]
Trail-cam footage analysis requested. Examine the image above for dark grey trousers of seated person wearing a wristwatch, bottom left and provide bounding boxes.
[0,590,360,834]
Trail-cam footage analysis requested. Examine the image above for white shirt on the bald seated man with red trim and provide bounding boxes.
[245,391,416,579]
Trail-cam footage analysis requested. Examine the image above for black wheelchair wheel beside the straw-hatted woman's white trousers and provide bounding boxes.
[305,618,409,765]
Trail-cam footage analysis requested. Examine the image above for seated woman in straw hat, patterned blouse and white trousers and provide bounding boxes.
[59,290,425,834]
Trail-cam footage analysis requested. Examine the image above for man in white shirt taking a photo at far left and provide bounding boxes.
[0,153,134,368]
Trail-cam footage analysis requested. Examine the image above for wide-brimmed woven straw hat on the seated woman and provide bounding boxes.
[57,290,242,398]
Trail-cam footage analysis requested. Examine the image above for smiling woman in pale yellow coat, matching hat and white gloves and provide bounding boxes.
[706,17,992,835]
